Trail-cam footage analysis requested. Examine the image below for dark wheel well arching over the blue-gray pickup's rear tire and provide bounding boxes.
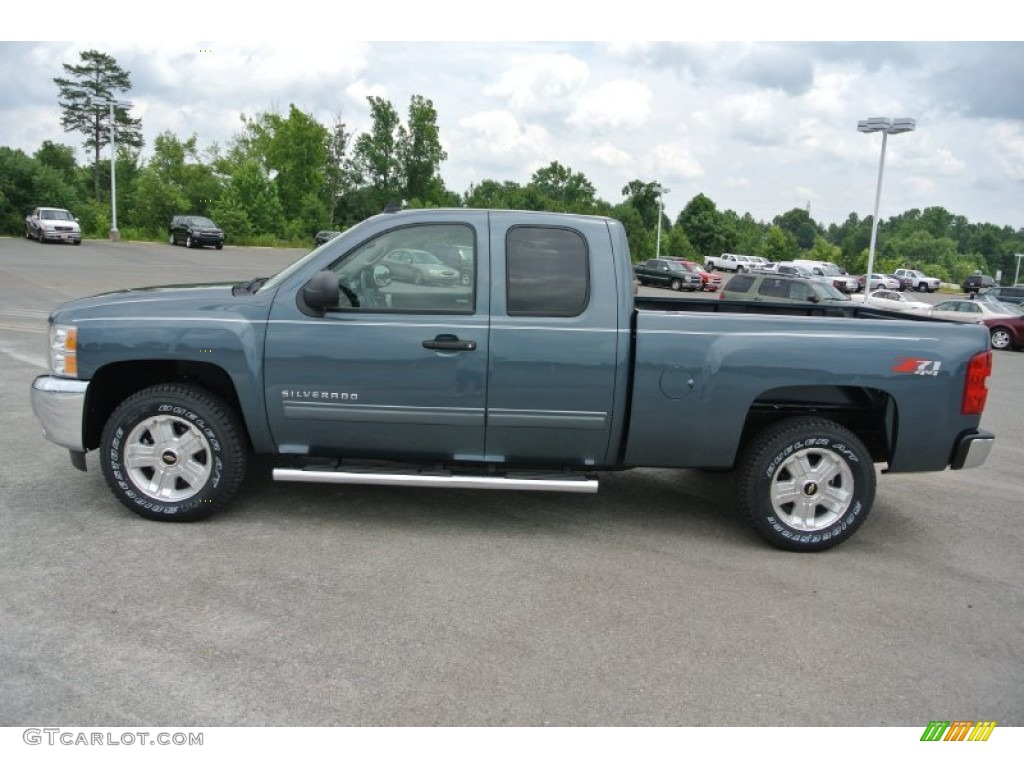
[740,386,897,462]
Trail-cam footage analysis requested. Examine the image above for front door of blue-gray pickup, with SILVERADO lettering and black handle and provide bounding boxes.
[264,211,489,460]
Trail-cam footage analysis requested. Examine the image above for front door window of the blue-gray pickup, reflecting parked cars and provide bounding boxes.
[323,224,476,313]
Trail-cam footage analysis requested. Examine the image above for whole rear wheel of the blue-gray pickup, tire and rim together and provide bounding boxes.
[739,418,874,552]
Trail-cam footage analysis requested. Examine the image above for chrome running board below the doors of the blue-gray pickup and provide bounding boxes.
[273,467,597,494]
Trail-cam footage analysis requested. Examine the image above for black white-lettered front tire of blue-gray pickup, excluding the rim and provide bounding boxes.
[100,384,246,522]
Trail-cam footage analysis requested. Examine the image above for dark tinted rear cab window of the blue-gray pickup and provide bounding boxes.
[505,226,590,317]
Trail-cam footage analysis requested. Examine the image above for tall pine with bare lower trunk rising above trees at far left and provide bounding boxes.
[53,50,142,200]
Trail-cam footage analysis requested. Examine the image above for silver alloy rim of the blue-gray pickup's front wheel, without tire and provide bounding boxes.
[125,416,213,502]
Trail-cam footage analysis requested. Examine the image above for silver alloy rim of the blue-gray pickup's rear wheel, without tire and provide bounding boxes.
[771,447,854,530]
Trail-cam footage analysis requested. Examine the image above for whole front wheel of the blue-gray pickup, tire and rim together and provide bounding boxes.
[100,384,248,522]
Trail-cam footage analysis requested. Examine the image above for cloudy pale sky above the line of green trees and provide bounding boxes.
[0,6,1024,227]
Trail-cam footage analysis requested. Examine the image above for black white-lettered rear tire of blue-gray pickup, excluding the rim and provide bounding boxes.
[740,419,876,552]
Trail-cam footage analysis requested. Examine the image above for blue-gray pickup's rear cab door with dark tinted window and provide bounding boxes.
[486,217,630,466]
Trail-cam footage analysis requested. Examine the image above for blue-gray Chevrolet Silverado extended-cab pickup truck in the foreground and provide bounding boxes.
[32,209,994,551]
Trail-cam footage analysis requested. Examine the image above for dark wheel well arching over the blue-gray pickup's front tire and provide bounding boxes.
[84,360,249,451]
